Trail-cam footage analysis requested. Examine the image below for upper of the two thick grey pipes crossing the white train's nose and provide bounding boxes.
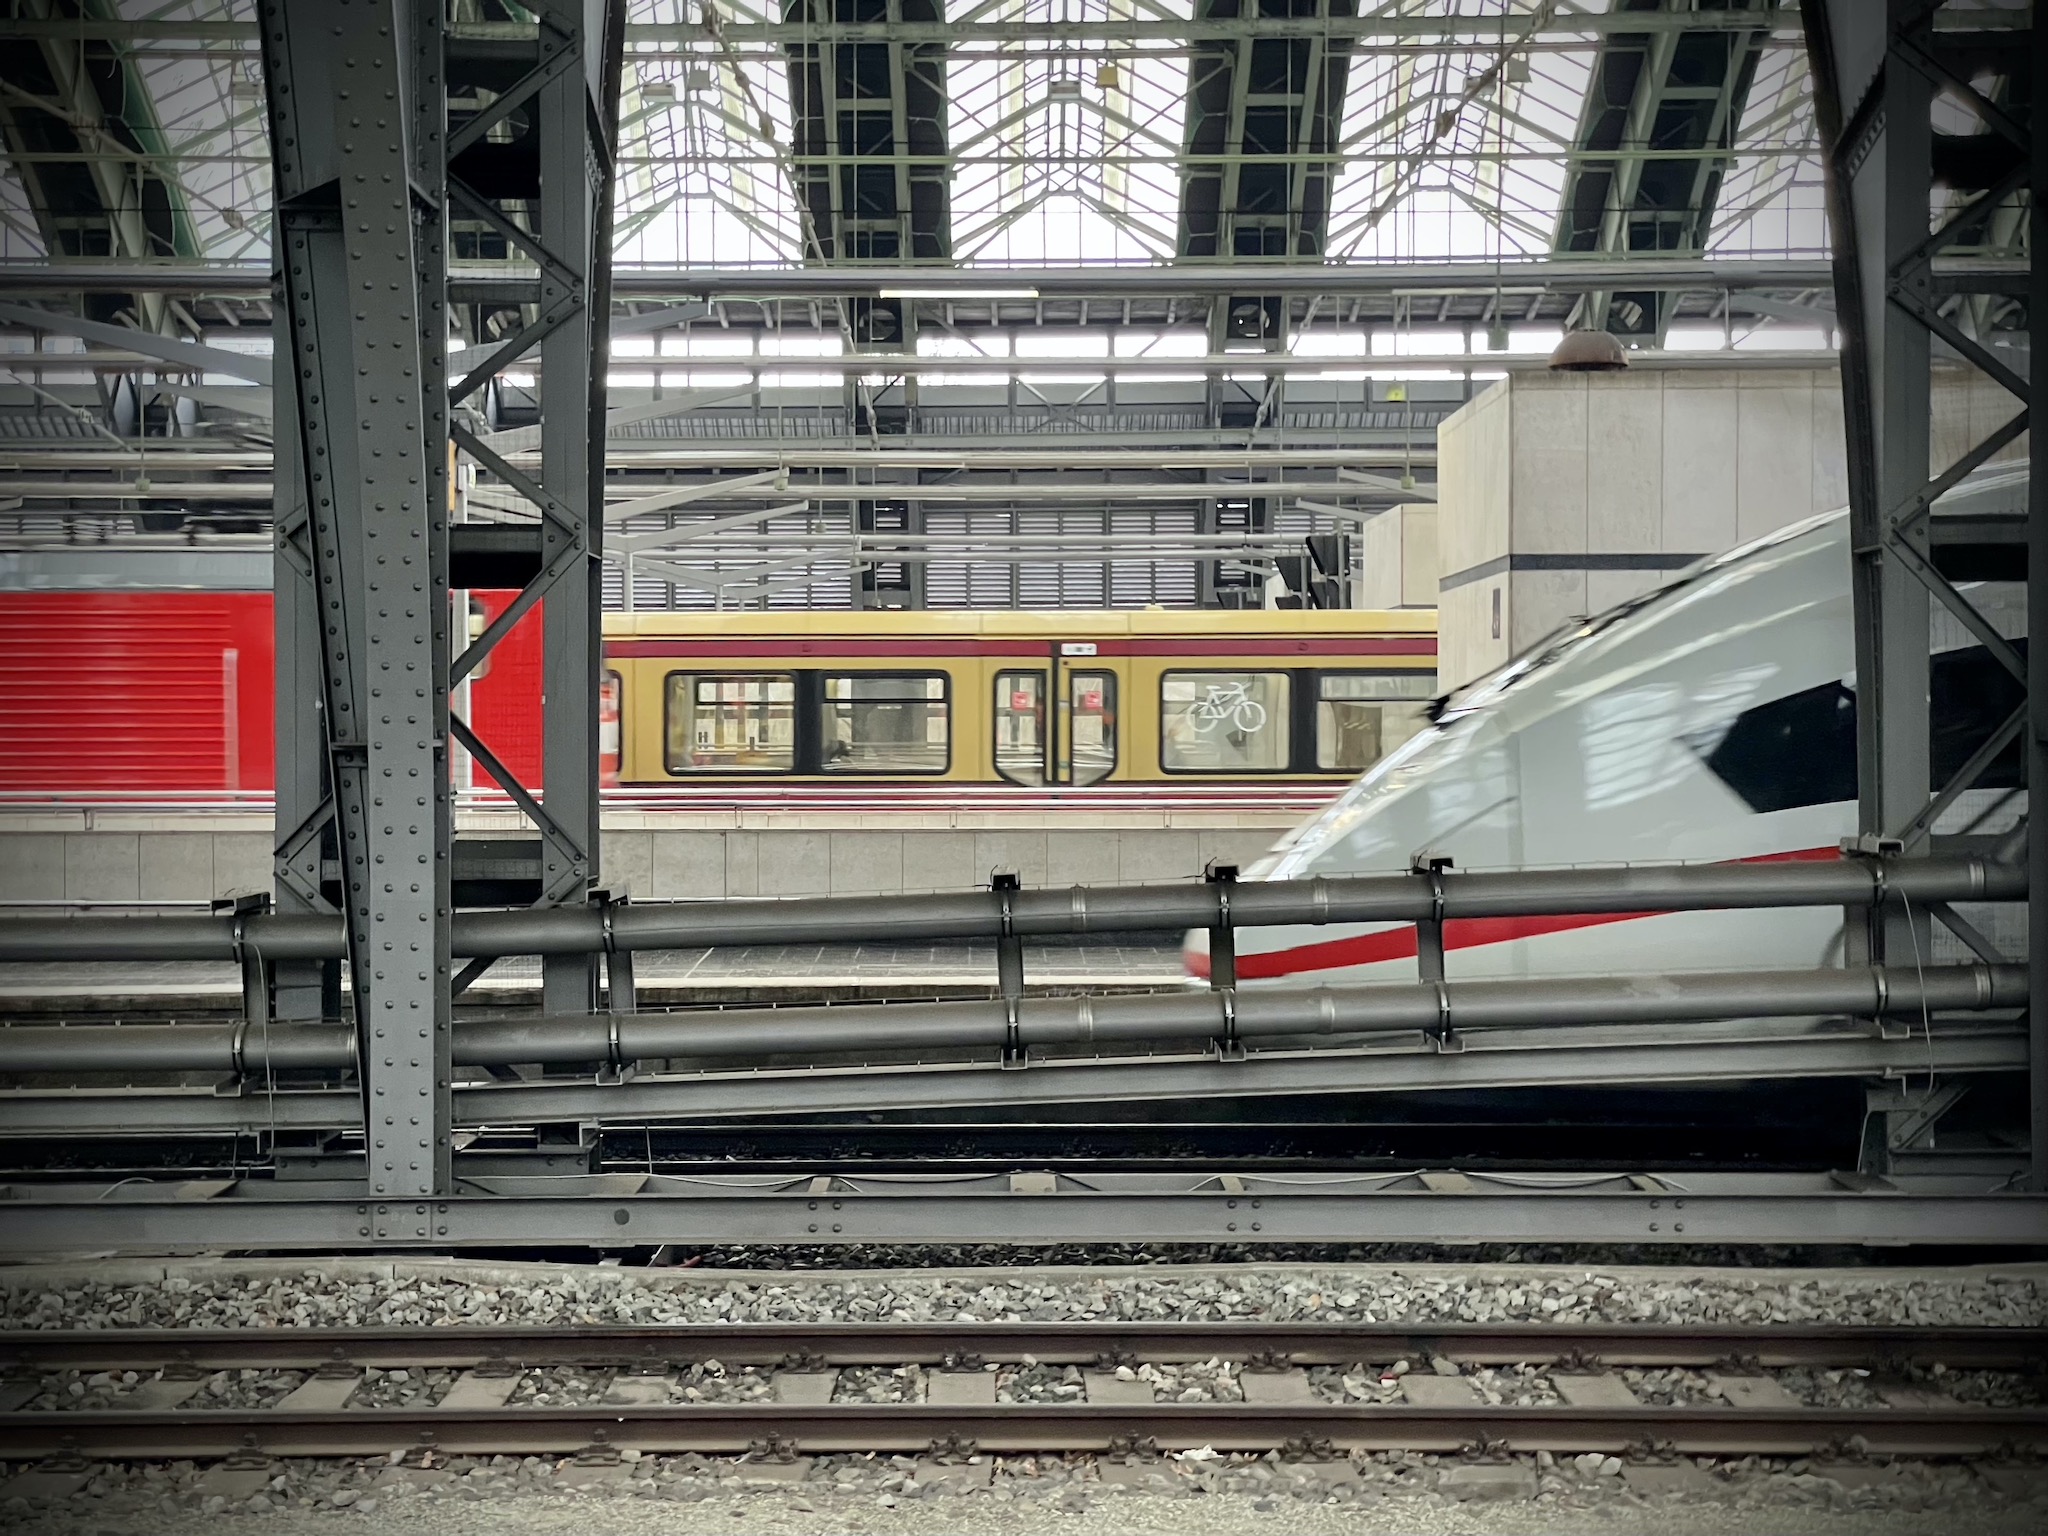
[0,856,2028,961]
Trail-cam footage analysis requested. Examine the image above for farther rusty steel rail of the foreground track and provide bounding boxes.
[0,1321,2048,1374]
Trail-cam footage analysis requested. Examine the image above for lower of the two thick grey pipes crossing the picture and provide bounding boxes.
[0,965,2028,1073]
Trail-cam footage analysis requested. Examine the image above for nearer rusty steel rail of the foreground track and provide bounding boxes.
[0,1403,2048,1458]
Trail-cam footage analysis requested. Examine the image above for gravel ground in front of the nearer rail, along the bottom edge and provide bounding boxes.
[0,1450,2048,1536]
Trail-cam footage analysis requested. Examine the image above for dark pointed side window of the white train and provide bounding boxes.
[1694,641,2028,813]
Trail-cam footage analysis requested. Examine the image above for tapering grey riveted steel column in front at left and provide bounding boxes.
[258,0,451,1204]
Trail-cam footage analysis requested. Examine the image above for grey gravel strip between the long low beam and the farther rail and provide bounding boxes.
[0,1260,2048,1329]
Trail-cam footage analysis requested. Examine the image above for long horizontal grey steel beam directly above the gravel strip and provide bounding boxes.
[0,1169,2048,1253]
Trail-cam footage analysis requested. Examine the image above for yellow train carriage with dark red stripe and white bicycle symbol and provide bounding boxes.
[604,610,1436,788]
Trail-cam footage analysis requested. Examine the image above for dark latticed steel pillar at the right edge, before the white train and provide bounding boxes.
[1800,0,2048,1188]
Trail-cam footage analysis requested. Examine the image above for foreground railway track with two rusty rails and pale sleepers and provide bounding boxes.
[0,1323,2048,1460]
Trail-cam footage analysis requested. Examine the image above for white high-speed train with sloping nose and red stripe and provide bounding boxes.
[1186,471,2025,985]
